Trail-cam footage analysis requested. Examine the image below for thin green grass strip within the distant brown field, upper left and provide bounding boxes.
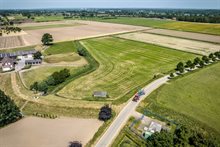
[21,23,81,31]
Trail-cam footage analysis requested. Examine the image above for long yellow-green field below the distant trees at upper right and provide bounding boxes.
[84,17,220,35]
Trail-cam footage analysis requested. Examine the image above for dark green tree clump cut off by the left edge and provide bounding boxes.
[0,90,22,127]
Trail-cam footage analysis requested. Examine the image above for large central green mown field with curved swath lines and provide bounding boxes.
[58,37,195,100]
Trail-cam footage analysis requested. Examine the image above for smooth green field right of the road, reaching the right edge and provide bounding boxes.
[140,63,220,134]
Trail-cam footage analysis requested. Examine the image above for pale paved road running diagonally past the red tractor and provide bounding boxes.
[96,76,169,147]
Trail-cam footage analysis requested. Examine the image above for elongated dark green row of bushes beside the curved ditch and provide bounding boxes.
[30,68,70,93]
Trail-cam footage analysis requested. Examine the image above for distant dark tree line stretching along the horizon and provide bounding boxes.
[0,8,220,23]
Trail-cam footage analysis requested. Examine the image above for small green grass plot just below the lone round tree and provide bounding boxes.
[44,41,76,55]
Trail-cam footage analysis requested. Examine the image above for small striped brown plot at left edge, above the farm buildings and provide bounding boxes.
[0,36,26,49]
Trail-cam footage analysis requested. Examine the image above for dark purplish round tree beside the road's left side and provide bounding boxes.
[99,105,112,121]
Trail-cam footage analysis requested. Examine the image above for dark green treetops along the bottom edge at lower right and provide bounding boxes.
[146,126,218,147]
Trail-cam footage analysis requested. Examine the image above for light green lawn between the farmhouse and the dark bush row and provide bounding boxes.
[22,66,77,87]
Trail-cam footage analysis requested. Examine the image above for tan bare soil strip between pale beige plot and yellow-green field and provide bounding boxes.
[145,29,220,43]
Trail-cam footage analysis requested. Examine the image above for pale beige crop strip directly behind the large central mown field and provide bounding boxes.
[119,32,220,55]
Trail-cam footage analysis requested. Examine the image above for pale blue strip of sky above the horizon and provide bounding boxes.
[0,0,220,10]
